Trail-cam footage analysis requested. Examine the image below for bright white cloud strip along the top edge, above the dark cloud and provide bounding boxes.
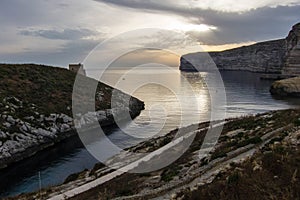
[94,0,300,15]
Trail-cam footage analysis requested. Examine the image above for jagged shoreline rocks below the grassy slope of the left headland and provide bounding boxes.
[0,94,144,169]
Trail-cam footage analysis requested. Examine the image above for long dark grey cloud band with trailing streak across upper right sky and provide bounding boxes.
[95,0,300,45]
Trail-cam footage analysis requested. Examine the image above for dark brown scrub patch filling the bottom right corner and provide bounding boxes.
[182,146,300,200]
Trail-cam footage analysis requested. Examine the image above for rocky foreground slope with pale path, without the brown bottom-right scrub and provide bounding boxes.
[9,110,300,199]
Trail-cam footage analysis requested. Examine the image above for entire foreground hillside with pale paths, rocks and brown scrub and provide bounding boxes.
[11,110,300,200]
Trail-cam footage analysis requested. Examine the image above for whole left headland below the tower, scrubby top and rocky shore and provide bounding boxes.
[0,64,144,169]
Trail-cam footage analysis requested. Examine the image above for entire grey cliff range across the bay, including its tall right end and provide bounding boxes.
[180,21,300,75]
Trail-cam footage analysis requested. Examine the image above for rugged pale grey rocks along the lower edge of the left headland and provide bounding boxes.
[0,94,144,169]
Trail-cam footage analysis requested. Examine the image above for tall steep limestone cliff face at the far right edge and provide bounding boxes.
[282,23,300,76]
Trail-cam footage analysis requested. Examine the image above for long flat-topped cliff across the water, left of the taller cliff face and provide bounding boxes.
[180,39,286,73]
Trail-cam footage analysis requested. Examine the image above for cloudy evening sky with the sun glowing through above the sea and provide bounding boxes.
[0,0,300,67]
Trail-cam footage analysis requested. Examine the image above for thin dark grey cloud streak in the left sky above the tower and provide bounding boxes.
[19,28,101,40]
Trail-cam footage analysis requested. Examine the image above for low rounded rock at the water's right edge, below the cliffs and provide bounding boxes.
[270,77,300,97]
